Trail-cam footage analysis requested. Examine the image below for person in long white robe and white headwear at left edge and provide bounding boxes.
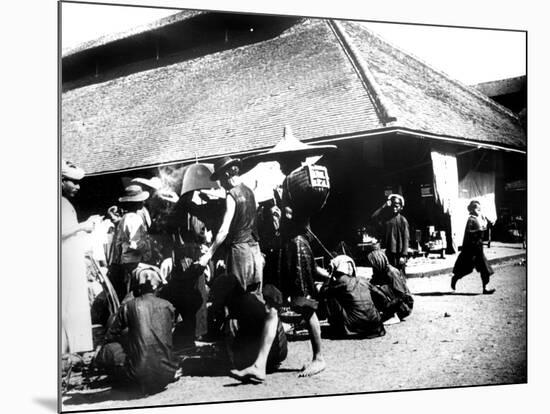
[61,160,99,353]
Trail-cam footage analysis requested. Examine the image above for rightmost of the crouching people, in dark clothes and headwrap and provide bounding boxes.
[367,249,414,325]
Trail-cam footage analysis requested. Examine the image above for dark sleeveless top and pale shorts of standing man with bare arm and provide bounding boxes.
[226,184,263,291]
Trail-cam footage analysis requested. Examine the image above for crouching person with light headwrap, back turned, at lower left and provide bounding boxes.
[96,264,178,394]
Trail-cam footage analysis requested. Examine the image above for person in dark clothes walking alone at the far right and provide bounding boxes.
[451,200,495,295]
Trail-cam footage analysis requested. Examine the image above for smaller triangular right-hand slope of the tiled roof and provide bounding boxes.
[343,22,526,148]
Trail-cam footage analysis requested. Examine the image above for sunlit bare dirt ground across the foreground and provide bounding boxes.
[63,261,527,411]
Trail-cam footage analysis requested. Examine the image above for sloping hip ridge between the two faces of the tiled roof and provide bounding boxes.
[326,19,397,125]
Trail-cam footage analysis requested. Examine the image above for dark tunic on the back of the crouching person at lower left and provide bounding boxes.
[98,293,178,391]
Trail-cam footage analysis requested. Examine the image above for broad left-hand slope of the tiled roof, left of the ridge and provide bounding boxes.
[62,20,381,172]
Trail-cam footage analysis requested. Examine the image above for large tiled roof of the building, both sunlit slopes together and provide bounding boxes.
[62,15,525,173]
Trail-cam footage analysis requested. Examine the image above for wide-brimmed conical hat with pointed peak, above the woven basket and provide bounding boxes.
[243,126,336,170]
